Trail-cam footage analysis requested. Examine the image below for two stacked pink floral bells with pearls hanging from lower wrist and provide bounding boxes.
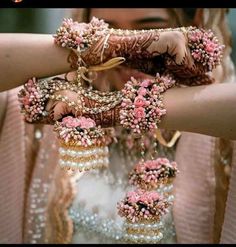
[117,143,178,243]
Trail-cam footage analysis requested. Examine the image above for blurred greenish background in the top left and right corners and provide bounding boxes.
[0,8,236,65]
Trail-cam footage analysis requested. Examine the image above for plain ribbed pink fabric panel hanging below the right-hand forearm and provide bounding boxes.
[173,133,215,243]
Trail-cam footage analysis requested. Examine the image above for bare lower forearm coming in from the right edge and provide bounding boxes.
[160,83,236,140]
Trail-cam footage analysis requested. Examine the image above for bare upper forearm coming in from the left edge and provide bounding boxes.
[0,33,70,91]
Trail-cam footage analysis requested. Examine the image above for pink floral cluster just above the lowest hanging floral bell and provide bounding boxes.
[129,158,178,190]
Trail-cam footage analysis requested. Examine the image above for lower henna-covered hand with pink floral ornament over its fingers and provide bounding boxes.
[18,77,120,127]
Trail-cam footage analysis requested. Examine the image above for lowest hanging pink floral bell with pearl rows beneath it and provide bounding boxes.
[117,189,170,243]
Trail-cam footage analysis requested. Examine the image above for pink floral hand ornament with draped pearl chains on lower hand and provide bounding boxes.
[18,77,122,127]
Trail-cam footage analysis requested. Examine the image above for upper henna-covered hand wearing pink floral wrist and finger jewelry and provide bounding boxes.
[55,18,223,78]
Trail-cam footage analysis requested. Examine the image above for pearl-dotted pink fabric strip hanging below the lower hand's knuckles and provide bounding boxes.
[24,125,58,244]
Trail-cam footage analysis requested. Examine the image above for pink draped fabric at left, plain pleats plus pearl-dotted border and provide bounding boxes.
[0,88,58,243]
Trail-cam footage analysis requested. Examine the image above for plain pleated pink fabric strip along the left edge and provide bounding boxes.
[0,88,26,243]
